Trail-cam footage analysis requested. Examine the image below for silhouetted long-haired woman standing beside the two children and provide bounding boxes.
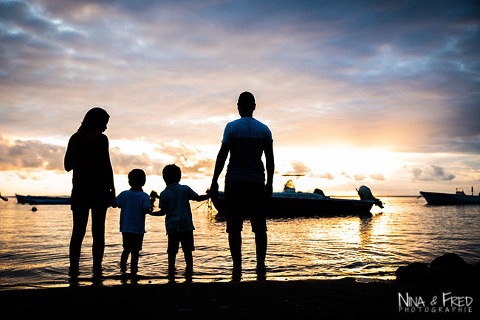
[64,108,115,278]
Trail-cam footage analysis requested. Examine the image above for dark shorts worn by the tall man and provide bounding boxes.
[225,181,267,233]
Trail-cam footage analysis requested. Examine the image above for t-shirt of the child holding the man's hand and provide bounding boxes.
[158,183,198,234]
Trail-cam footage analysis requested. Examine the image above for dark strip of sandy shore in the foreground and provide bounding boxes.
[0,279,480,319]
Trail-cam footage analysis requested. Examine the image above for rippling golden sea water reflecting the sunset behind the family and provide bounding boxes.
[0,197,480,290]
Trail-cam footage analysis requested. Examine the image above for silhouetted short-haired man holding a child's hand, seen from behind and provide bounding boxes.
[210,92,275,281]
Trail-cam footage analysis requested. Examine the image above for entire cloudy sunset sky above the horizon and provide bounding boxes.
[0,0,480,195]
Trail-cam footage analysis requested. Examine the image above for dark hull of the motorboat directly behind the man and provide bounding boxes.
[212,192,374,217]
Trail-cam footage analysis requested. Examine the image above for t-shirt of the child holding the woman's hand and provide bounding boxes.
[115,190,150,233]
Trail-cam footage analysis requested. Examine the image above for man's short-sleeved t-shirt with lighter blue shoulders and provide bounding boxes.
[222,117,273,183]
